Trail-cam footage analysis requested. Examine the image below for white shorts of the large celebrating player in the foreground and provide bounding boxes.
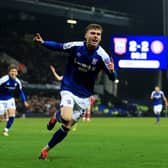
[60,91,90,121]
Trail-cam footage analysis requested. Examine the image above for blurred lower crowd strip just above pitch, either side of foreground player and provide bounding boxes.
[13,91,144,117]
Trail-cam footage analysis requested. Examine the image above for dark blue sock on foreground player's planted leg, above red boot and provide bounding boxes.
[48,125,69,149]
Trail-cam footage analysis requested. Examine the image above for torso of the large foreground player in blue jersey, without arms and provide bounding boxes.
[62,46,103,97]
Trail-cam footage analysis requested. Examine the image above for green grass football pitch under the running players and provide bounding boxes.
[0,118,168,168]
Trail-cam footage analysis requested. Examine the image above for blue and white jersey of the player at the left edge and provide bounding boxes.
[0,75,26,102]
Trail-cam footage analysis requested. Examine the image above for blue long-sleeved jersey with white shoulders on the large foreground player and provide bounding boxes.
[43,41,116,97]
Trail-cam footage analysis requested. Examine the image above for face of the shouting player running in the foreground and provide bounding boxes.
[85,29,102,49]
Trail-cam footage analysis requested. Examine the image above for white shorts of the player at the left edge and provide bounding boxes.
[0,98,16,115]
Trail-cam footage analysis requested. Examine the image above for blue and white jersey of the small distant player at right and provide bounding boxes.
[151,91,164,105]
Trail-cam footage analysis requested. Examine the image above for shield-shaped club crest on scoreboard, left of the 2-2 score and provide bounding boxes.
[114,37,127,55]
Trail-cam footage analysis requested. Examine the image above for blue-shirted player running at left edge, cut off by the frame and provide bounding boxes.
[0,64,29,136]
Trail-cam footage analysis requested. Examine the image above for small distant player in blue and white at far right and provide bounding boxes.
[150,86,168,123]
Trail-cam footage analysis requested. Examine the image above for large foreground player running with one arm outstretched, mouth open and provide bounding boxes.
[34,24,116,159]
